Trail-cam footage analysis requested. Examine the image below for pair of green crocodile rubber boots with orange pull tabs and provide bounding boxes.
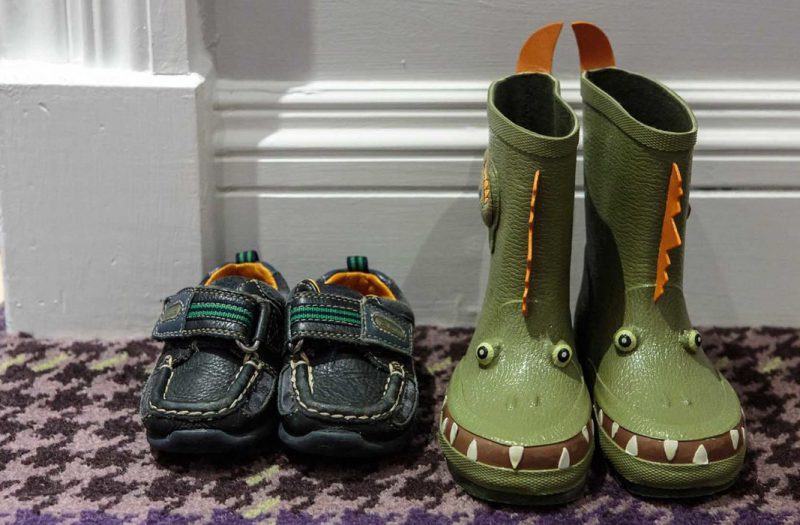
[438,22,746,504]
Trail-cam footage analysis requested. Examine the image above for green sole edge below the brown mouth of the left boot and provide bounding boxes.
[437,433,594,506]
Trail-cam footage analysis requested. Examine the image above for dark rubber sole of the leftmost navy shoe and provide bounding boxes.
[147,424,275,454]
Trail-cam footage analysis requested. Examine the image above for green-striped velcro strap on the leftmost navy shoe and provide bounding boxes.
[153,287,281,352]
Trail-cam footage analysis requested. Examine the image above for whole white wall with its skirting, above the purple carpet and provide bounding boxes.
[0,0,800,337]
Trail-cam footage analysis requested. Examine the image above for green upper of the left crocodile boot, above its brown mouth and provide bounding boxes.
[440,73,591,448]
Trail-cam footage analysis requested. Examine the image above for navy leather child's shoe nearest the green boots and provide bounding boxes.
[278,257,419,457]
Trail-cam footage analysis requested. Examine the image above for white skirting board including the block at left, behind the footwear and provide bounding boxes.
[0,75,800,337]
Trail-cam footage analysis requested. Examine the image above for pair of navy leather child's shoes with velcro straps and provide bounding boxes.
[140,251,418,456]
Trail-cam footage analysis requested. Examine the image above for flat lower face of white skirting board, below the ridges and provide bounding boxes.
[220,190,800,326]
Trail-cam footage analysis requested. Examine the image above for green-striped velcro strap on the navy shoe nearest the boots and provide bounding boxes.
[287,292,414,356]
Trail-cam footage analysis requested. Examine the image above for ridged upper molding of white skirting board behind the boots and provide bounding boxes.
[214,79,800,191]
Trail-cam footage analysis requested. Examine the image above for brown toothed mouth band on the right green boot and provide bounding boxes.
[597,408,746,465]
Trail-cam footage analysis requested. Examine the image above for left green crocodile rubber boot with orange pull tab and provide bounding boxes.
[439,24,594,505]
